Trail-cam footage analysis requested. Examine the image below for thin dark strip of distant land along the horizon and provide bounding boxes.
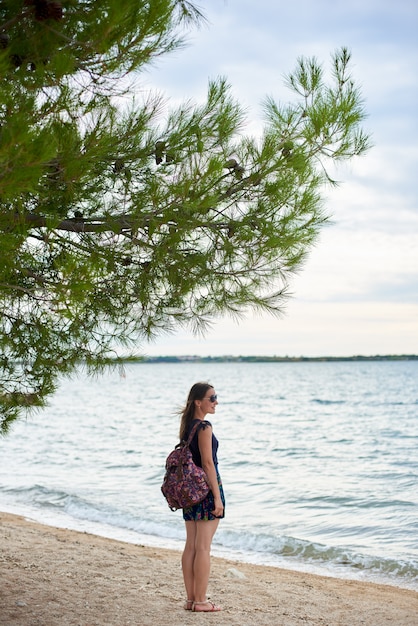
[122,354,418,363]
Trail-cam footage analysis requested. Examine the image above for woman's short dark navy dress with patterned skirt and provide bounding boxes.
[183,420,225,522]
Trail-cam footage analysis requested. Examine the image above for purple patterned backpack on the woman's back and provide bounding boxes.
[161,416,210,511]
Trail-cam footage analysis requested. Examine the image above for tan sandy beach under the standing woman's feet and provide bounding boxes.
[0,513,418,626]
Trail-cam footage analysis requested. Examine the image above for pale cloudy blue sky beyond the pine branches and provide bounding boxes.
[140,0,418,357]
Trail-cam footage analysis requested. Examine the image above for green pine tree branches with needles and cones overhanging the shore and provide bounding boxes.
[0,0,368,432]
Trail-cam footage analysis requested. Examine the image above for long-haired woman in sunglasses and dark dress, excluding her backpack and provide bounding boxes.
[180,383,225,612]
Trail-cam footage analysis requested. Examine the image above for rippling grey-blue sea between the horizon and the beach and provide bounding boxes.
[0,360,418,590]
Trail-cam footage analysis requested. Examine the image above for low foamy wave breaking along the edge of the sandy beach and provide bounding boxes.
[3,485,418,589]
